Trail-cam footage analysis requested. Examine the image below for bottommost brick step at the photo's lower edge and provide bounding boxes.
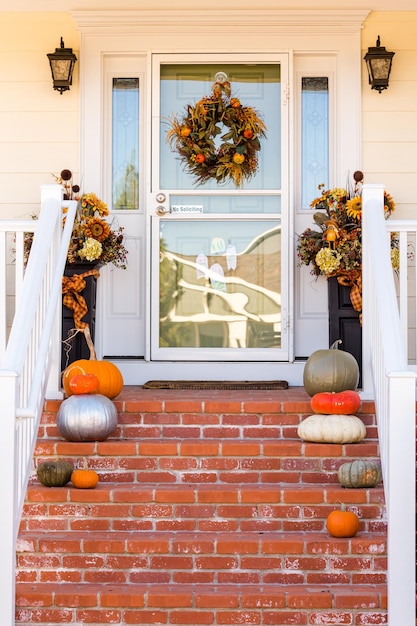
[16,583,387,626]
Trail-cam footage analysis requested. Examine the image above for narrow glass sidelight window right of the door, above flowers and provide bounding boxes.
[301,77,329,209]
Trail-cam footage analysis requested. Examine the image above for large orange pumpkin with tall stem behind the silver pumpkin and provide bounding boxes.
[62,359,123,400]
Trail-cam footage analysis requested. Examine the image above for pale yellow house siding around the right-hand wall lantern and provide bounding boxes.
[362,11,417,219]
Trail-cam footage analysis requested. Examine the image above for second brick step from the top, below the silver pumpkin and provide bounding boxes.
[30,438,379,484]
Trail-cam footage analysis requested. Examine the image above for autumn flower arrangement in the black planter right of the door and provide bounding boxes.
[297,172,399,311]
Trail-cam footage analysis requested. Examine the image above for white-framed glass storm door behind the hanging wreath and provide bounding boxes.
[149,54,290,362]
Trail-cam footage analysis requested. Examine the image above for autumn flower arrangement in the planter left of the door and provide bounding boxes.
[25,169,127,269]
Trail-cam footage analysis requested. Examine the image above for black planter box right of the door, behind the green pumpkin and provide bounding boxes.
[327,278,362,387]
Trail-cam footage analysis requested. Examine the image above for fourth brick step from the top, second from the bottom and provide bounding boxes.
[17,531,387,585]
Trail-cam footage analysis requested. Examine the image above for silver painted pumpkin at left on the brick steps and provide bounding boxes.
[57,393,117,441]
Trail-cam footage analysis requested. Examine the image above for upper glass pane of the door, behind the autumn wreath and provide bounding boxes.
[160,63,281,190]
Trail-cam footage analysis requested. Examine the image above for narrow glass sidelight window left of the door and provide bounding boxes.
[112,78,139,209]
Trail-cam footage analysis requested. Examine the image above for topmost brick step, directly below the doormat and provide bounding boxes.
[39,387,377,440]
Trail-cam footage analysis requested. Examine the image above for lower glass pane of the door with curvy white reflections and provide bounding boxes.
[159,220,281,348]
